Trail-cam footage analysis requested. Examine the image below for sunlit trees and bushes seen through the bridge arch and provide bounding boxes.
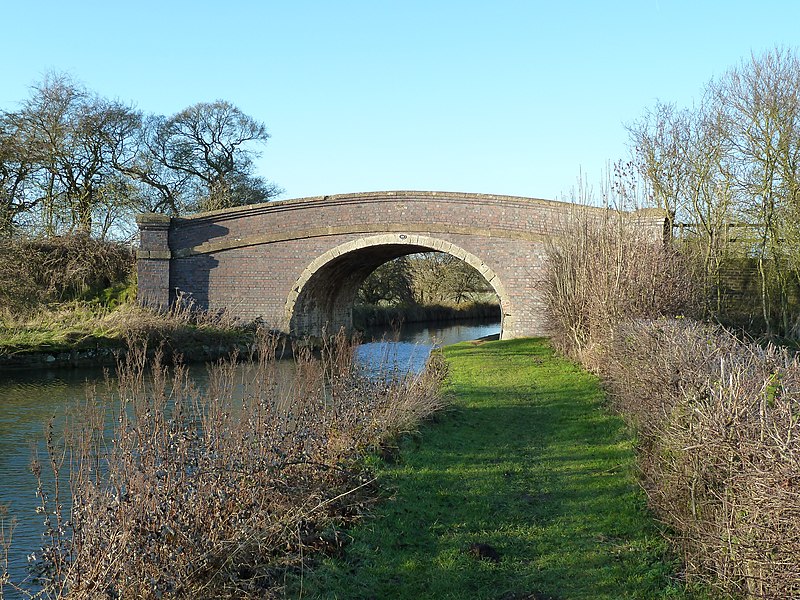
[358,252,492,305]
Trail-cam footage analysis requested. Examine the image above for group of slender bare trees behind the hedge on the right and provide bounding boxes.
[628,48,800,336]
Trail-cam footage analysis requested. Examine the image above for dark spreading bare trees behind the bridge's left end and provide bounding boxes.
[0,74,282,237]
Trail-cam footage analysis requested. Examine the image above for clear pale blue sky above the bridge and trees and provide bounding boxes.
[0,0,800,203]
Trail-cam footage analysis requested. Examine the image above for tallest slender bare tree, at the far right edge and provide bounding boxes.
[712,48,800,334]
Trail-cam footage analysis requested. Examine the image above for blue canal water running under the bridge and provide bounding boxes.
[0,321,500,598]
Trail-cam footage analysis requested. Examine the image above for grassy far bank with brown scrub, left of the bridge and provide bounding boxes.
[0,235,255,369]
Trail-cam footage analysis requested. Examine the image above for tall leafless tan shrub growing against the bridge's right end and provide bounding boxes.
[546,208,696,370]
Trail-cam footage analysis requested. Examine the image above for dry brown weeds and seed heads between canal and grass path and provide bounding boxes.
[17,330,443,599]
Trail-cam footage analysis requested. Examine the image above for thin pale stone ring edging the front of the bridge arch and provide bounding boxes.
[282,233,511,337]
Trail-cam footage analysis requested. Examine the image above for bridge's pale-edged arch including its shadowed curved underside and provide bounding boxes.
[283,233,513,337]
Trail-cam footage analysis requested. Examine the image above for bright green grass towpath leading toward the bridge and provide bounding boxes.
[287,340,705,600]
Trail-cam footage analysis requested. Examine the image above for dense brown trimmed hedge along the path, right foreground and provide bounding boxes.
[604,320,800,600]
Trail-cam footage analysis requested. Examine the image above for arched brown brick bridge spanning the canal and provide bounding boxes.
[138,192,665,338]
